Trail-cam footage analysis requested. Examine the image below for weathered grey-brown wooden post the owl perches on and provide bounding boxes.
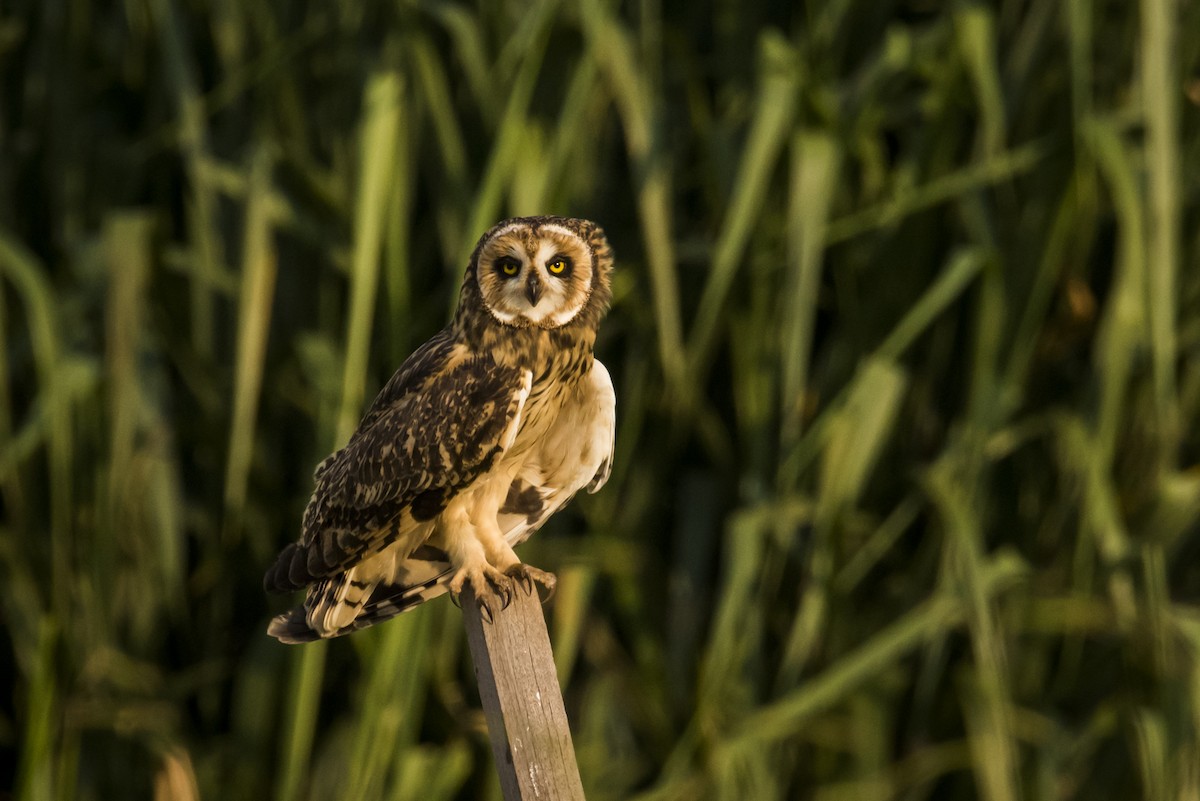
[462,585,583,801]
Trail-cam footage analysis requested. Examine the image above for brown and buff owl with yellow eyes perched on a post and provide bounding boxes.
[264,217,616,643]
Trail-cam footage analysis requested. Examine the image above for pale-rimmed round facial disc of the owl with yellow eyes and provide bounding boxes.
[475,218,596,329]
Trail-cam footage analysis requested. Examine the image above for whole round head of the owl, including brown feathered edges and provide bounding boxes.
[461,217,612,329]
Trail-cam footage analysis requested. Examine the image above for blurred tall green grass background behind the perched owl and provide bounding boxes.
[0,0,1200,801]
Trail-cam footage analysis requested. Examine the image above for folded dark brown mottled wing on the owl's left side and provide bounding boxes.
[263,354,529,591]
